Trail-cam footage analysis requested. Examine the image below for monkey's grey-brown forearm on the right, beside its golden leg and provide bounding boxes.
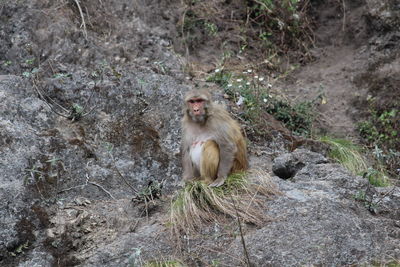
[210,141,236,187]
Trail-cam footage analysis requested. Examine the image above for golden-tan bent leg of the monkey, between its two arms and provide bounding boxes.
[200,140,219,184]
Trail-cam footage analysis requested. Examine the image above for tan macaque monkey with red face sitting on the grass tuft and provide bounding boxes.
[182,90,248,187]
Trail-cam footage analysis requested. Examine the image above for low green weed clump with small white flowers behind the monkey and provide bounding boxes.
[207,69,315,136]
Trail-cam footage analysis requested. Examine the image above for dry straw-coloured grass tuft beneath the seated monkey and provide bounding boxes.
[170,170,279,234]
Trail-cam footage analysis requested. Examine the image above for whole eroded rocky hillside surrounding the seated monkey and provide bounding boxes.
[0,0,400,266]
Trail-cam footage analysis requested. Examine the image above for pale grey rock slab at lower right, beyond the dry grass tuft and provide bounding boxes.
[225,150,400,266]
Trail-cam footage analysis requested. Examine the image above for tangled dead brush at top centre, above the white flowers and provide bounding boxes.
[175,0,314,73]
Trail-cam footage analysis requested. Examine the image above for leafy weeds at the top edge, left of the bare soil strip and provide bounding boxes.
[178,0,314,60]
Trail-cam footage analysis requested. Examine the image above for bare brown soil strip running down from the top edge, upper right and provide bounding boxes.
[278,1,368,141]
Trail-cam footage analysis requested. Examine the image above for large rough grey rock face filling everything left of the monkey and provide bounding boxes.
[0,1,189,266]
